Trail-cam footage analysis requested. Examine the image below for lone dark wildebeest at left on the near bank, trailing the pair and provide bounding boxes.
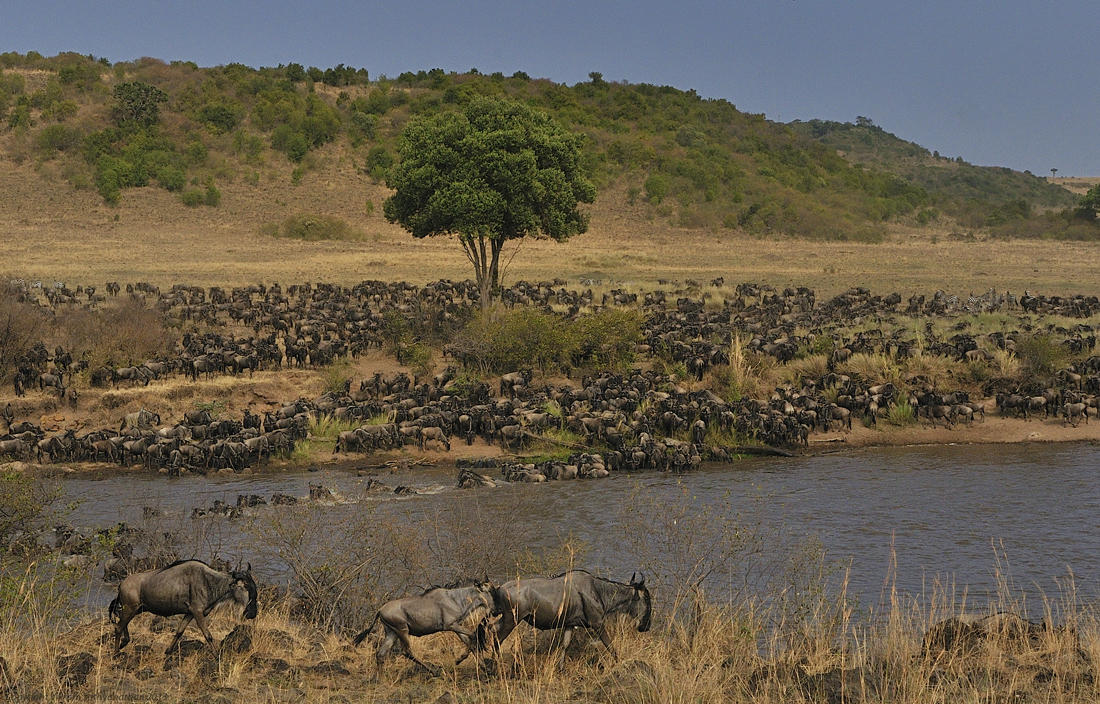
[107,560,256,652]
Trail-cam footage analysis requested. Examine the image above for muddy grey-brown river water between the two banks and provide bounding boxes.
[64,443,1100,604]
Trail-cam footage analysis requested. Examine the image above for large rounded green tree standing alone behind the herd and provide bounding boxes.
[384,98,596,305]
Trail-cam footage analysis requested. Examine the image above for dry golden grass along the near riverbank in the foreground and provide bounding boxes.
[0,567,1100,704]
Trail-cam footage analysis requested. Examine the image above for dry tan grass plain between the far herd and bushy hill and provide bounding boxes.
[0,151,1100,295]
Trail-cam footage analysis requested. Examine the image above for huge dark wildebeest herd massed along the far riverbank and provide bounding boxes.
[0,275,1100,482]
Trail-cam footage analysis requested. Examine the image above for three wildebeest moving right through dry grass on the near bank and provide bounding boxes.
[107,560,652,671]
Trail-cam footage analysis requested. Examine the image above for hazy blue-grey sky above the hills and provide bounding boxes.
[0,0,1100,176]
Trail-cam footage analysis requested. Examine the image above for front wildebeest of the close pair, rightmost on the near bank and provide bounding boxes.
[491,570,653,655]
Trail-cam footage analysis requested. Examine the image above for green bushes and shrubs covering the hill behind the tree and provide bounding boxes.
[0,52,1095,241]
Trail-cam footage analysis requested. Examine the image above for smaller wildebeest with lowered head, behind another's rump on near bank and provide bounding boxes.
[352,582,495,672]
